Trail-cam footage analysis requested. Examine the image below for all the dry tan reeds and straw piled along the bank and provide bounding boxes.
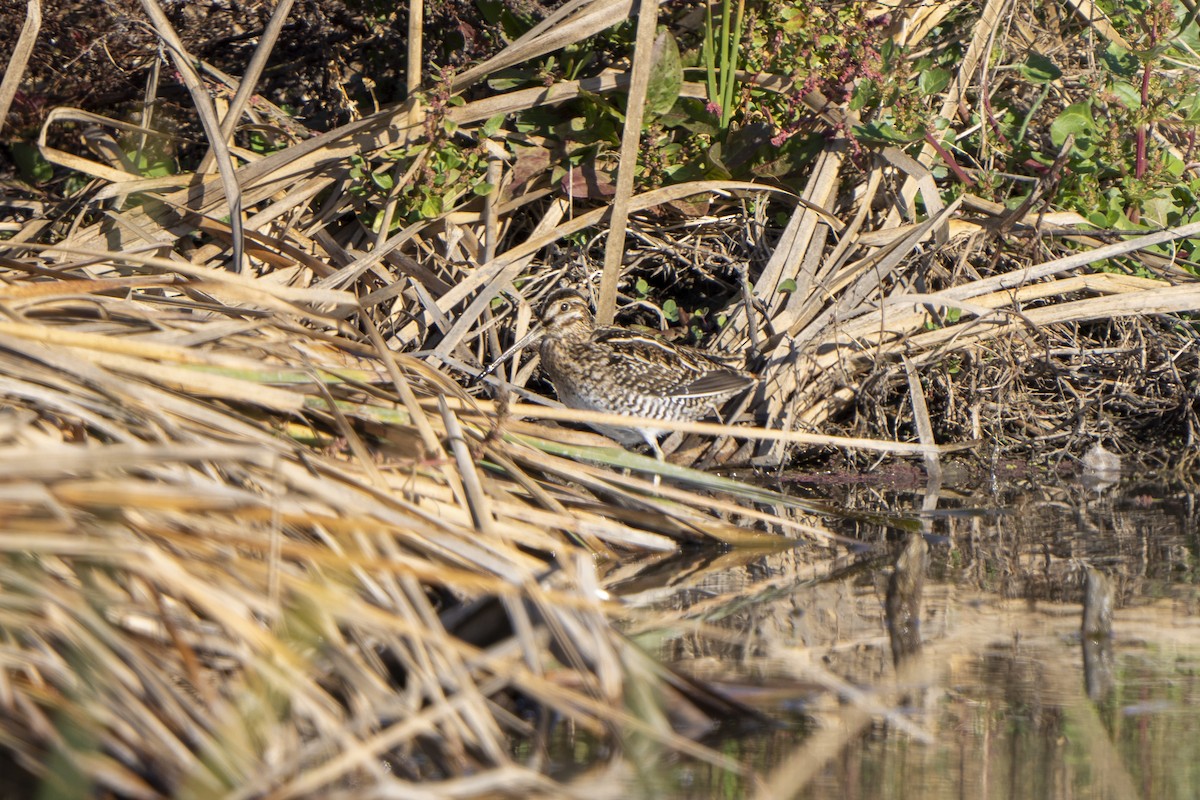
[0,0,1200,798]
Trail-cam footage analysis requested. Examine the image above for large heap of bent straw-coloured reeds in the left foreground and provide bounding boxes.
[0,231,796,795]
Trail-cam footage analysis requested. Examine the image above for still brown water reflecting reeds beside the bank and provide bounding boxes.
[552,465,1200,800]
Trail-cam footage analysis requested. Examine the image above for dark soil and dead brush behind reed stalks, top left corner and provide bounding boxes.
[0,0,520,178]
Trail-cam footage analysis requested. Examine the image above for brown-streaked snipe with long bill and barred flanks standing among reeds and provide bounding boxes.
[475,289,756,461]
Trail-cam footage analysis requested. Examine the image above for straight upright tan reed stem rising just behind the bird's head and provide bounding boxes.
[596,0,659,325]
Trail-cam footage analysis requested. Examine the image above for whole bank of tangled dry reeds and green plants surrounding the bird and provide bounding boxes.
[0,0,1200,798]
